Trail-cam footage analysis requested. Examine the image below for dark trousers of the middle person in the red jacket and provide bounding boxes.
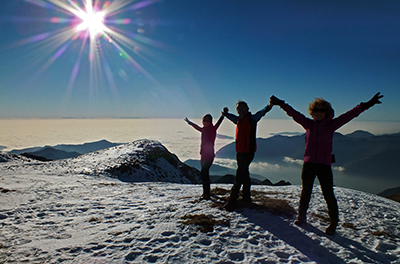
[229,152,254,202]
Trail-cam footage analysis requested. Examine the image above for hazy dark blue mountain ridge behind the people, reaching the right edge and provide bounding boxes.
[216,130,400,179]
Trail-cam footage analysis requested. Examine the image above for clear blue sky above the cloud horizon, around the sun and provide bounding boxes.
[0,0,400,121]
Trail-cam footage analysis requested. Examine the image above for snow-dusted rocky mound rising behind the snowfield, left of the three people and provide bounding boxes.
[57,139,200,183]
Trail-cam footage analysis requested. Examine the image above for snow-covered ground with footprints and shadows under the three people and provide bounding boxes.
[0,140,400,264]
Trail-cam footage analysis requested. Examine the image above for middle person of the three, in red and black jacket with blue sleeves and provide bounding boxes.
[223,101,272,211]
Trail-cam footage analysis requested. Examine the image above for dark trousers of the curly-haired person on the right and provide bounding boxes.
[299,162,339,222]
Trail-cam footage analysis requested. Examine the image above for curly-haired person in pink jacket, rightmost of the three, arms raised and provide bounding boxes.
[270,93,383,235]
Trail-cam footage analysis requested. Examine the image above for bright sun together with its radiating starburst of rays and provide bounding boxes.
[12,0,162,94]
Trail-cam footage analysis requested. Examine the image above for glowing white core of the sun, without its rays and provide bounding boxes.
[76,6,107,37]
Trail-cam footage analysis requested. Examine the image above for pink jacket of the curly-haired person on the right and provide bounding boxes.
[282,104,366,165]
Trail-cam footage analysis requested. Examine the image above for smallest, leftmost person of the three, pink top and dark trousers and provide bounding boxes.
[184,114,224,200]
